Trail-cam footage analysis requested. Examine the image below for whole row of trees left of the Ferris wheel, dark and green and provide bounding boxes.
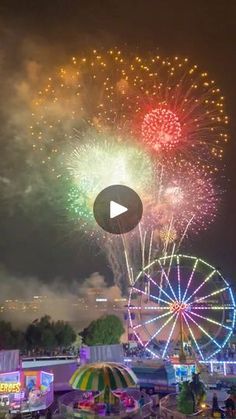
[0,314,125,354]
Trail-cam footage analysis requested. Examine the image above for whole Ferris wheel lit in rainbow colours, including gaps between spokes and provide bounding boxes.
[128,254,236,360]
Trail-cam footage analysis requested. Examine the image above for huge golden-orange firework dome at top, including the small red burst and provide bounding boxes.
[30,49,228,171]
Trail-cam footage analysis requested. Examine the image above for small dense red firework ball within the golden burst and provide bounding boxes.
[142,107,182,150]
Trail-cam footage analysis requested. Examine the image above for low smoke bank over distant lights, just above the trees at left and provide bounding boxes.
[0,269,121,331]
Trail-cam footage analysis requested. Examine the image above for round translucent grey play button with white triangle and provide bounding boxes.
[93,185,143,234]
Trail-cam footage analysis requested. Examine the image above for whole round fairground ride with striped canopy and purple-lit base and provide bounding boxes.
[59,362,150,419]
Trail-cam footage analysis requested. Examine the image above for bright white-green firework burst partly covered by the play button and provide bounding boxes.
[67,133,154,241]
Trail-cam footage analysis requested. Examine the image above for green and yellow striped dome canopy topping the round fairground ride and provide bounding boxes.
[70,362,137,391]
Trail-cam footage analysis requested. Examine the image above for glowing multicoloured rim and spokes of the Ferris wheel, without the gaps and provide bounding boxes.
[128,254,236,360]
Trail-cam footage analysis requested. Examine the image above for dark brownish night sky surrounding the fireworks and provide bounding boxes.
[0,0,236,295]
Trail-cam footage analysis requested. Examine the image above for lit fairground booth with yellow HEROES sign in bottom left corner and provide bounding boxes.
[0,350,53,413]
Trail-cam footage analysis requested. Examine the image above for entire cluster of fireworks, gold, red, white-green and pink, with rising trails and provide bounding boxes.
[27,48,225,292]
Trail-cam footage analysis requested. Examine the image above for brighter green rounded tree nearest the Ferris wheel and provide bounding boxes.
[81,315,125,346]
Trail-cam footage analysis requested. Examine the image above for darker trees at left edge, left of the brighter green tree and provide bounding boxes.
[0,316,77,353]
